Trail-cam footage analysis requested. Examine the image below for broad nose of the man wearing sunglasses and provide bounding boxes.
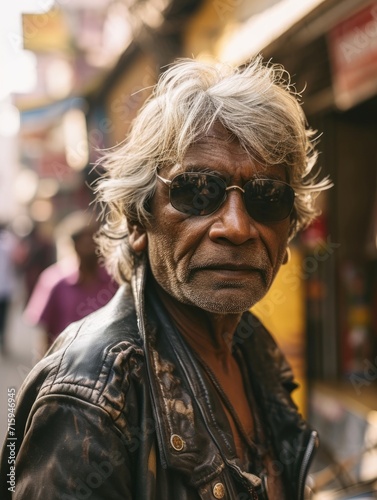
[209,189,259,245]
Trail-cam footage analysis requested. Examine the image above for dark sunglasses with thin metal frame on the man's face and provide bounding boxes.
[157,172,295,222]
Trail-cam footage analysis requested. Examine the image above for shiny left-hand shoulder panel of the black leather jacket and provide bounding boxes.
[19,285,144,430]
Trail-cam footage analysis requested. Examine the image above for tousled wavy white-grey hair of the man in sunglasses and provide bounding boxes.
[95,57,331,282]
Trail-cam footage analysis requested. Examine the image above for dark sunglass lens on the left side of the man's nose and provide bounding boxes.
[170,172,226,215]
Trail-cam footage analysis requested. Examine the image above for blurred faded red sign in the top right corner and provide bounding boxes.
[328,1,377,109]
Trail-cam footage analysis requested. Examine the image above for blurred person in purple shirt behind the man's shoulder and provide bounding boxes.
[24,214,118,347]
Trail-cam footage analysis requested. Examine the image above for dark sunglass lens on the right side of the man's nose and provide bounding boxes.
[244,179,295,222]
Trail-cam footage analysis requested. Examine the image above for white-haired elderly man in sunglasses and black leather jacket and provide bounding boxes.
[2,59,329,500]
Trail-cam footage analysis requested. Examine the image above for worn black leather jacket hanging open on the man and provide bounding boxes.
[0,260,317,500]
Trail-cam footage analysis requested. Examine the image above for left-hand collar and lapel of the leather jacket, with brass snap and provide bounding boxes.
[131,256,229,487]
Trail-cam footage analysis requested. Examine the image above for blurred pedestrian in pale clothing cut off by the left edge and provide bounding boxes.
[0,222,16,354]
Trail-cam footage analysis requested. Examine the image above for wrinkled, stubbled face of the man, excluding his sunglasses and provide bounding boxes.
[146,124,290,314]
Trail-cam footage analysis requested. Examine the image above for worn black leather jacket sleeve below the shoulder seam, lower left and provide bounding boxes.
[13,396,132,500]
